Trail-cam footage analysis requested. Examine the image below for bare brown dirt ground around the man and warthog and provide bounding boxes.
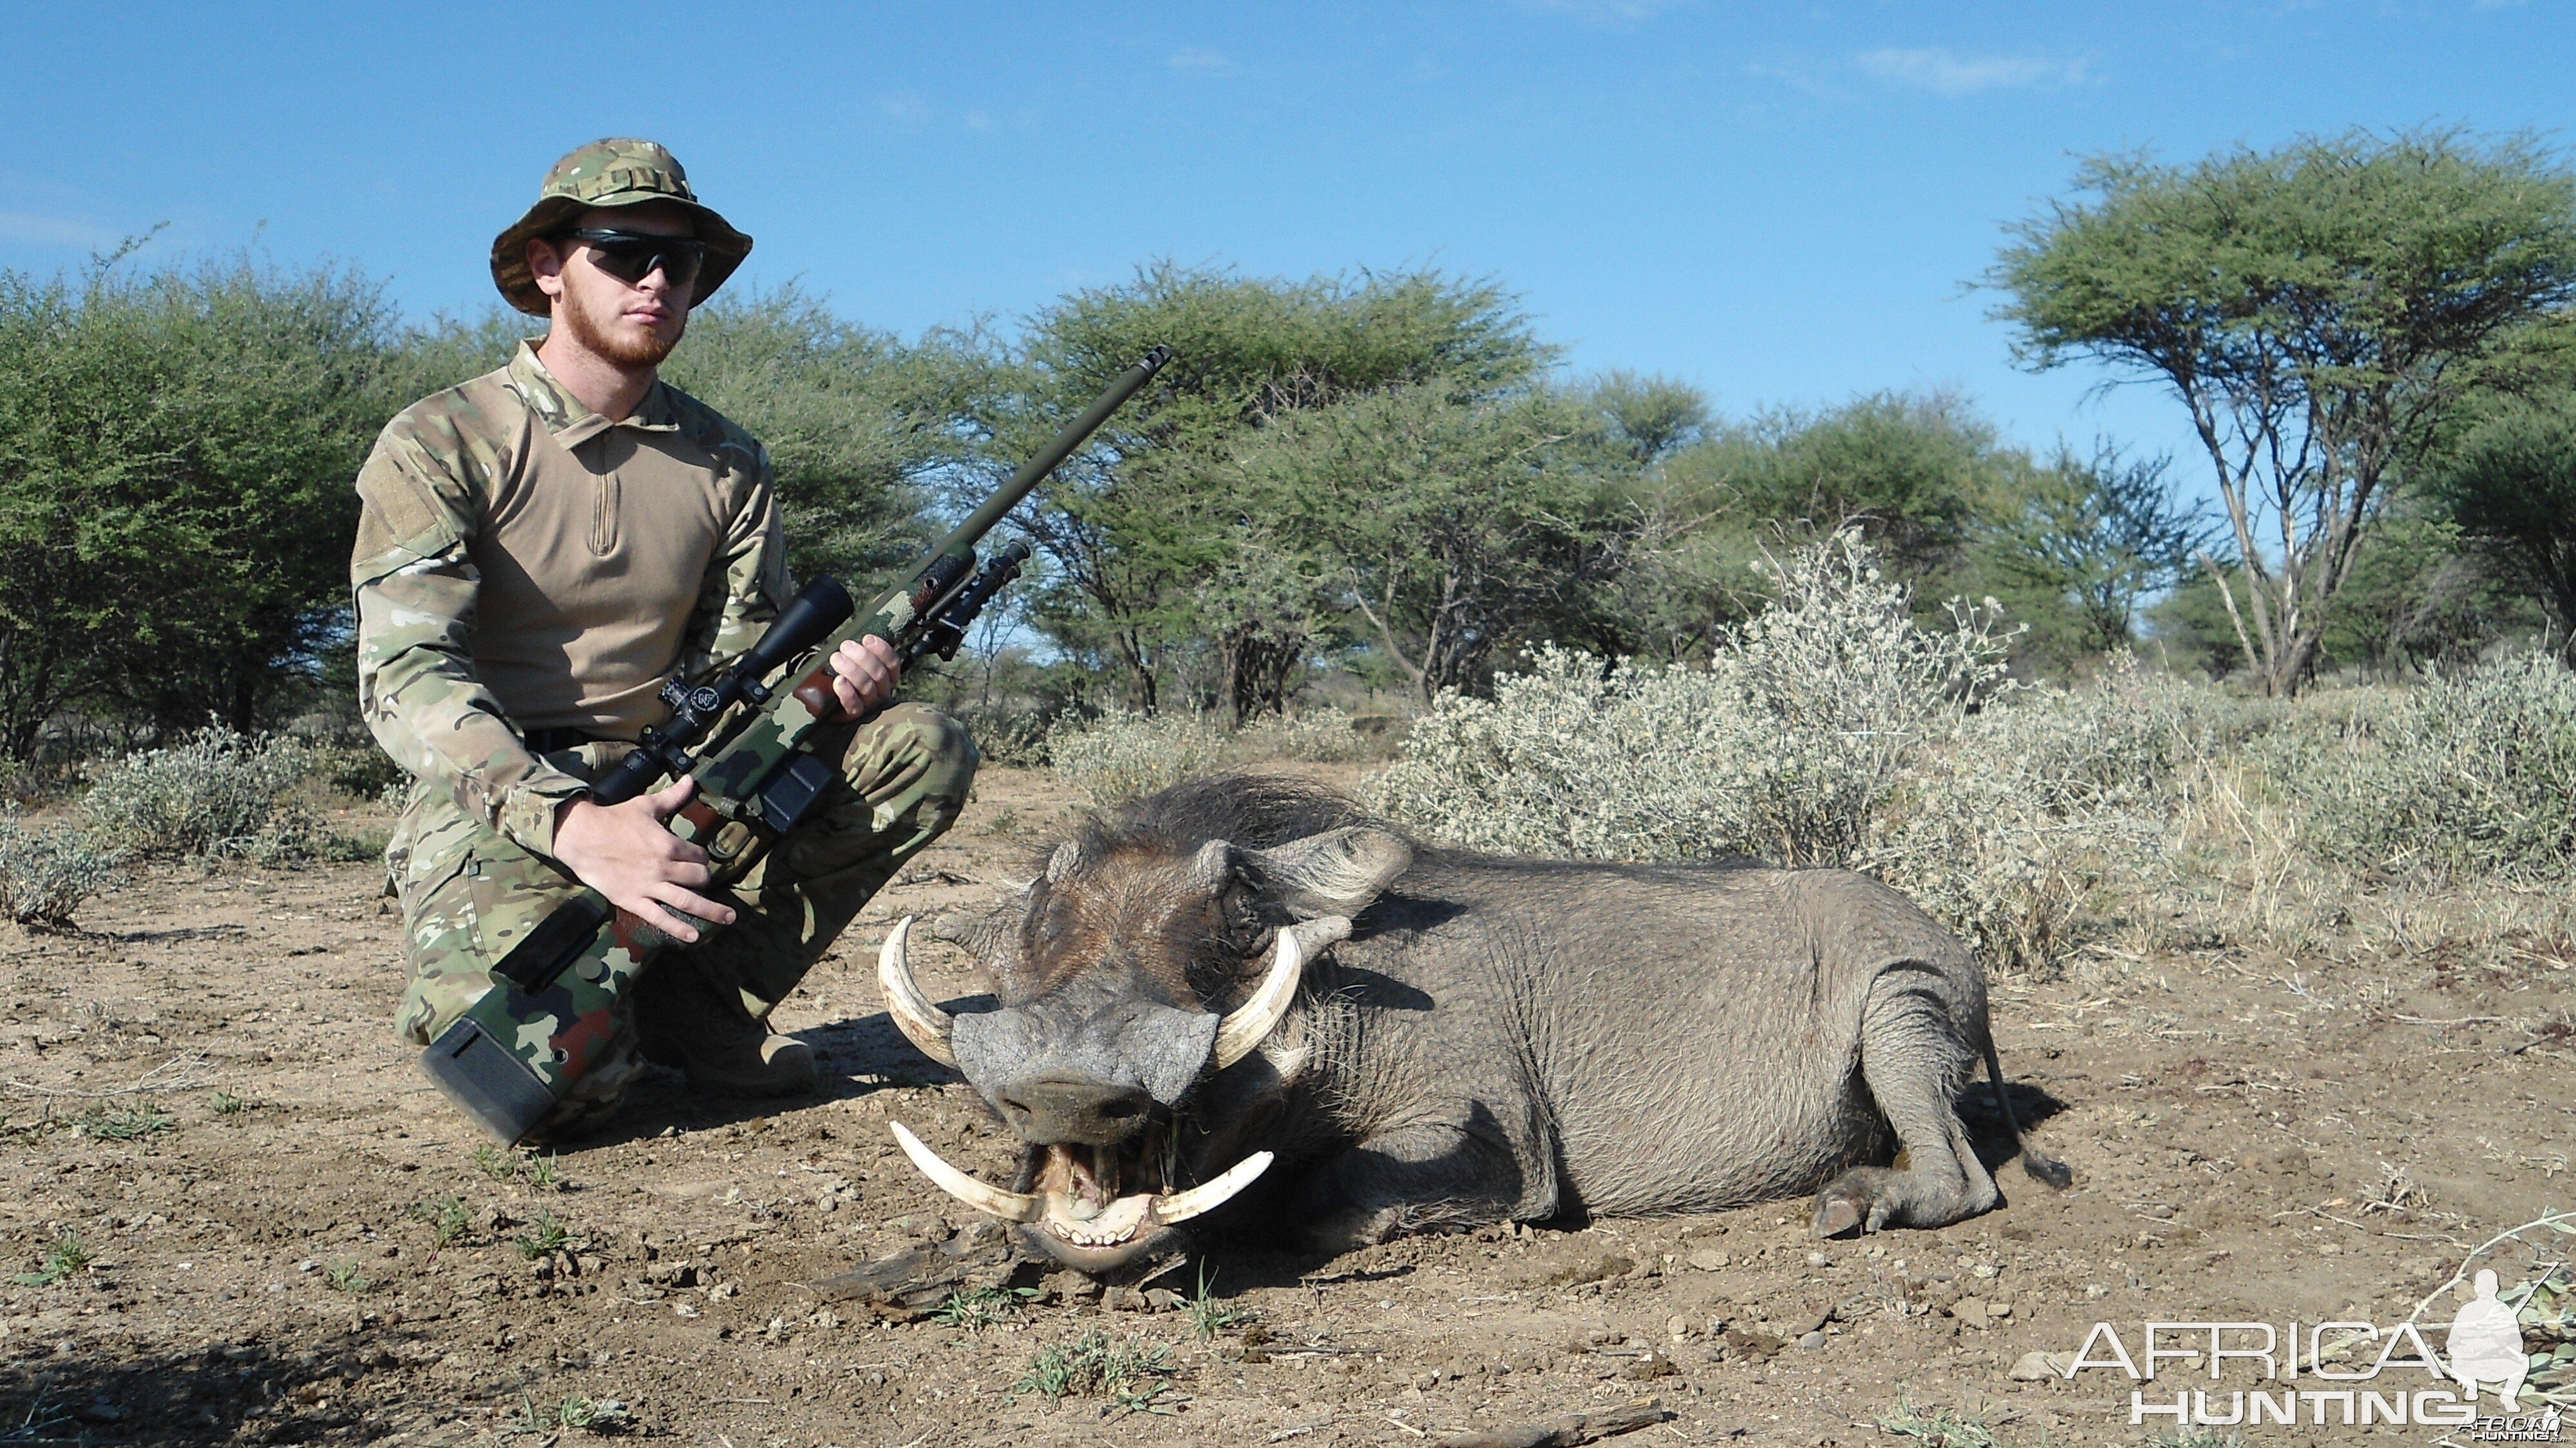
[0,770,2576,1448]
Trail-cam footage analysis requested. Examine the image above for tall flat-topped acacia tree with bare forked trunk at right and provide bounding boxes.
[1989,131,2576,693]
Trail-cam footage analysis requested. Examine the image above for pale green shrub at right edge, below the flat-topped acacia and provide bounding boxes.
[2259,649,2576,884]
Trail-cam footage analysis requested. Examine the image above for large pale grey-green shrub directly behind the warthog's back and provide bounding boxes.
[1370,533,2007,866]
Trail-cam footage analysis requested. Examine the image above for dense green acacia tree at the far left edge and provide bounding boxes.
[0,252,394,757]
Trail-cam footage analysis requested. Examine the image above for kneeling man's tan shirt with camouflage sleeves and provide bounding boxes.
[350,343,788,855]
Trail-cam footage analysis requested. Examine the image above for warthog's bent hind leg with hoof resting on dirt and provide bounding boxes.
[1816,971,2002,1237]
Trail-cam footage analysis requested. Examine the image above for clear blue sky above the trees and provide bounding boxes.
[0,0,2576,466]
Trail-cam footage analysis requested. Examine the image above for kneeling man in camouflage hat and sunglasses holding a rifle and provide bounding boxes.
[350,139,976,1139]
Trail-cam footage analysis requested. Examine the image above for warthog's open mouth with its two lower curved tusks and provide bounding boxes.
[889,1121,1270,1273]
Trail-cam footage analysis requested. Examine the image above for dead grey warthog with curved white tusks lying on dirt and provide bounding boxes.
[878,776,2069,1273]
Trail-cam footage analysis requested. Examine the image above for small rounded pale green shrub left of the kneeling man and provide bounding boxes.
[80,724,322,863]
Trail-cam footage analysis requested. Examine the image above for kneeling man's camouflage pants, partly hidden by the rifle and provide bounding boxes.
[384,703,976,1108]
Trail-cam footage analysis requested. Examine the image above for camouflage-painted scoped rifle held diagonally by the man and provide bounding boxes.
[420,348,1172,1144]
